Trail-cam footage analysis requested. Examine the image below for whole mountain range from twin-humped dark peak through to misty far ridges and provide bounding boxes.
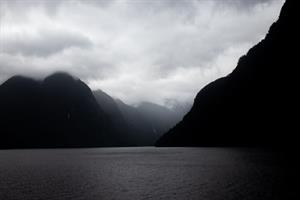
[0,73,188,148]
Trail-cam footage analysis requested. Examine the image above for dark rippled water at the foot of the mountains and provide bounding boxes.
[0,147,289,200]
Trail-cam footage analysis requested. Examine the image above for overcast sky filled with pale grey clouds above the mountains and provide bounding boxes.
[0,0,283,104]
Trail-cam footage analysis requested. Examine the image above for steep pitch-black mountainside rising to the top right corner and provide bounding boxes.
[156,0,299,146]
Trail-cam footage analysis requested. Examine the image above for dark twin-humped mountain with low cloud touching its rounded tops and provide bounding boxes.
[0,73,119,148]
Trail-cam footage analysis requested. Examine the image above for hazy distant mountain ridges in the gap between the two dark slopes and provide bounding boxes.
[93,90,189,146]
